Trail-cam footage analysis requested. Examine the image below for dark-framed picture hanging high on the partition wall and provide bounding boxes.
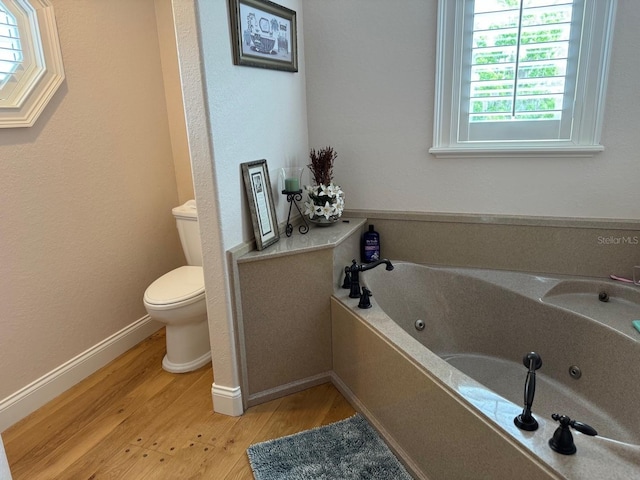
[229,0,298,72]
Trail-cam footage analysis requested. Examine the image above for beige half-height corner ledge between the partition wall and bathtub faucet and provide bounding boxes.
[229,218,366,408]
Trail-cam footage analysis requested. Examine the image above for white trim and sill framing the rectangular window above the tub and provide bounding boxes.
[429,0,617,157]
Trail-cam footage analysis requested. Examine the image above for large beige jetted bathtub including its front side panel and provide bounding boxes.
[332,262,640,480]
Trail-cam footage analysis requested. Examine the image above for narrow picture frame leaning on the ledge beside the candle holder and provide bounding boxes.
[241,160,280,250]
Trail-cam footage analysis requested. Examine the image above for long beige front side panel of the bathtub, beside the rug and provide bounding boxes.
[331,297,561,480]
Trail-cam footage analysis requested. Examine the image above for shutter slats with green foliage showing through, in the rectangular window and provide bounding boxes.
[469,0,573,122]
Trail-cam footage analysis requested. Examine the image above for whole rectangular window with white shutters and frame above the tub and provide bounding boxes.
[430,0,616,156]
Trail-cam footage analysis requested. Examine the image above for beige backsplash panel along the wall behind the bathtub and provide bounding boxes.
[345,210,640,278]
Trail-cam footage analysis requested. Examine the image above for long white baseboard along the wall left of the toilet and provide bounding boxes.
[0,315,162,432]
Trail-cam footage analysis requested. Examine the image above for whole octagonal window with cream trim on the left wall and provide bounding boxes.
[0,0,64,128]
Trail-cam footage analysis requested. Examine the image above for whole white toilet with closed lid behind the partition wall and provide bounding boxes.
[144,200,211,373]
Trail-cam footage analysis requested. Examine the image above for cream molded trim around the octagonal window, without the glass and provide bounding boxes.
[0,0,64,128]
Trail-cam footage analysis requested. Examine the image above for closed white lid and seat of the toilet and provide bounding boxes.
[144,265,204,309]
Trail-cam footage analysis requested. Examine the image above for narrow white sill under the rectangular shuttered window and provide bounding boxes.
[429,145,604,158]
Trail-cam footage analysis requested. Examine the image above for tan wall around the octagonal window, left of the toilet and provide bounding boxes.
[0,0,184,399]
